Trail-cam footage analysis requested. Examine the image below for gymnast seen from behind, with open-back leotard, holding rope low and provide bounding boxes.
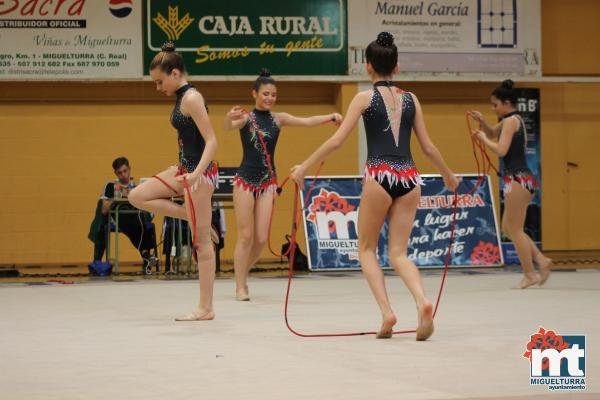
[291,32,459,340]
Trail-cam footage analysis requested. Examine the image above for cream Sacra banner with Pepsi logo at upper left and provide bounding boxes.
[0,0,142,80]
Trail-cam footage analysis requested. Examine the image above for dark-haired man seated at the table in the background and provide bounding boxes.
[94,157,158,273]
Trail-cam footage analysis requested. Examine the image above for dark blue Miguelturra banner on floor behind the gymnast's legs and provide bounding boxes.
[301,175,503,270]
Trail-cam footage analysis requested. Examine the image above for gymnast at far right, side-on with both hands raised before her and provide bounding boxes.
[470,80,552,289]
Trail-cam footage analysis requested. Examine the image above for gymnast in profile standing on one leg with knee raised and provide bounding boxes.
[129,42,218,321]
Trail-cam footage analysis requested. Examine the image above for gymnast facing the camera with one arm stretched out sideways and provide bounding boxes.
[225,69,342,301]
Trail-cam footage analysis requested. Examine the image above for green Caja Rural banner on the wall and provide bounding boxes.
[143,0,348,75]
